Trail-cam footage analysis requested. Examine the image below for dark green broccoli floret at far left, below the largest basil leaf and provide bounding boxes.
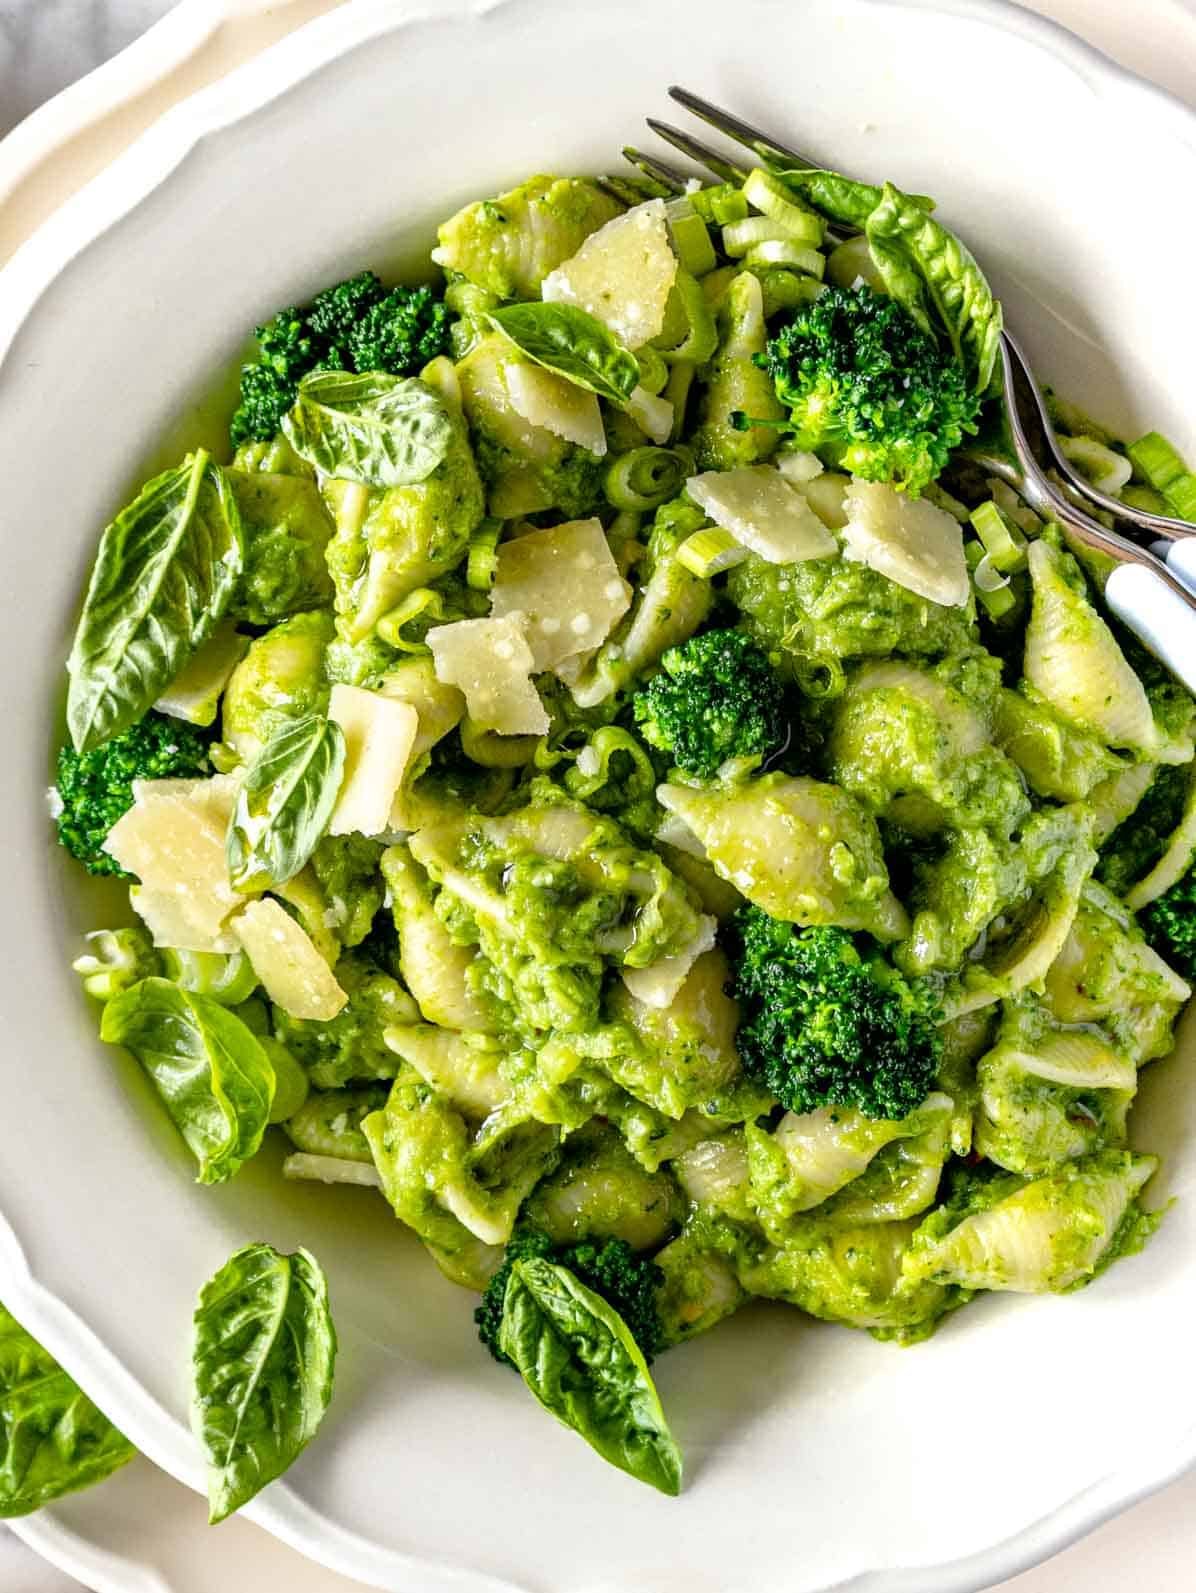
[54,709,212,878]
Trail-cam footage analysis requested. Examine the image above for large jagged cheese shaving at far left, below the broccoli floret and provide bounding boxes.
[104,774,245,951]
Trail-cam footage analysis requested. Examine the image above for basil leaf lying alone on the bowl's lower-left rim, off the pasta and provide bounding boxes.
[191,1244,336,1523]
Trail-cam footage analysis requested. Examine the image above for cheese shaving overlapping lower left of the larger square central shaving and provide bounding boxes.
[427,610,548,736]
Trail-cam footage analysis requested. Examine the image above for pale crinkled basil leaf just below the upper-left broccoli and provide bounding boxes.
[282,371,452,487]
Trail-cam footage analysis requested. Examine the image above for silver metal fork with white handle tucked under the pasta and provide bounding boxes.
[623,86,1196,691]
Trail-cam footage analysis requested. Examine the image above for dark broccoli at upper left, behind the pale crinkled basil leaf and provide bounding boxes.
[229,271,449,446]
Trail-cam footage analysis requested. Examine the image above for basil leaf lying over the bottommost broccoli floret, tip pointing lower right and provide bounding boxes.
[498,1258,682,1494]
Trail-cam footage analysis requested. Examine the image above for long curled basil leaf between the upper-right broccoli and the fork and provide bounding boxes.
[865,183,1002,392]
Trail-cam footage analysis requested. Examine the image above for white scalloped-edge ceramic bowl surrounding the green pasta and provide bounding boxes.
[0,0,1196,1593]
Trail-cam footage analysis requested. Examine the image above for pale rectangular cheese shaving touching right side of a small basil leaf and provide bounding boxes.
[328,685,419,835]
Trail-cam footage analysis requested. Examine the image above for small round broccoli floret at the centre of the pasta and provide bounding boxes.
[634,631,788,781]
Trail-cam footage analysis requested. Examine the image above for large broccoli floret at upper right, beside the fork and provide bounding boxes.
[748,284,979,494]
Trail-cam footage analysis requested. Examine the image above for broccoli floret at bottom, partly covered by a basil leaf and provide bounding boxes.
[473,1223,664,1365]
